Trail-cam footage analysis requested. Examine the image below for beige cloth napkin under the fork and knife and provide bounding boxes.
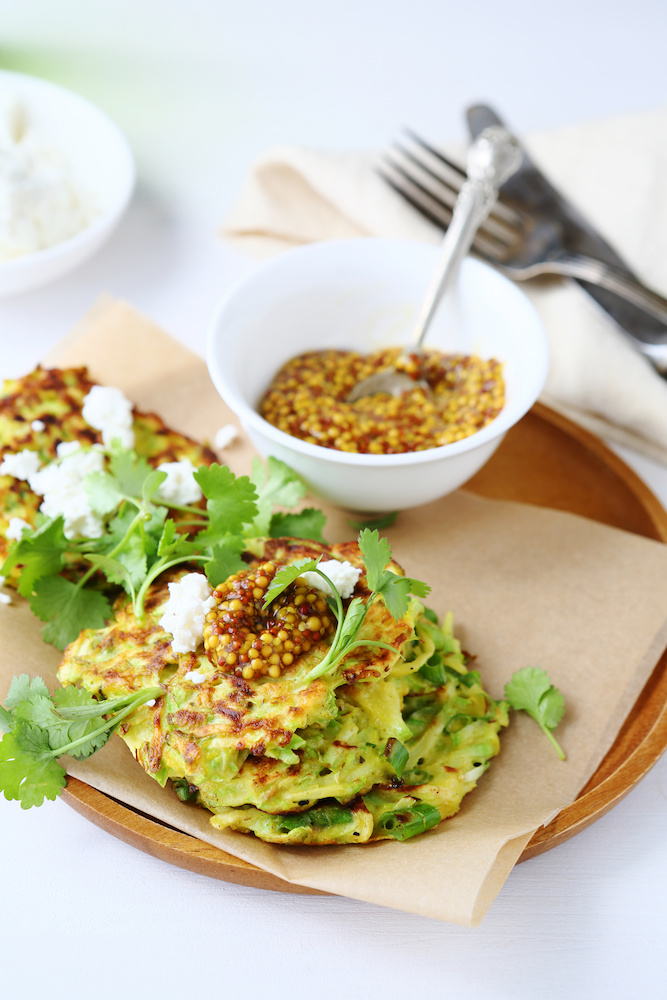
[224,108,667,464]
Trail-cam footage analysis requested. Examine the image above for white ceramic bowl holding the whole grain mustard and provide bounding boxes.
[208,239,548,512]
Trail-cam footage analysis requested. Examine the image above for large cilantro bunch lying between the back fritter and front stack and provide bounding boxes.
[0,444,325,649]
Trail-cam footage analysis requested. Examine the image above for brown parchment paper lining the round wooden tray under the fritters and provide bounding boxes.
[0,299,667,926]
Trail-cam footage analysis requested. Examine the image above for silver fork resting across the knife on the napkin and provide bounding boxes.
[379,129,667,330]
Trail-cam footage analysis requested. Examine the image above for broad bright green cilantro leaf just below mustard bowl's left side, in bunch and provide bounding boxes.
[194,463,257,545]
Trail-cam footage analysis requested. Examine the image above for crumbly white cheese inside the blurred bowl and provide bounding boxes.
[0,92,95,262]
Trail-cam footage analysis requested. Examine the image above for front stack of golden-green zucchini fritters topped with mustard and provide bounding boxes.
[59,539,507,844]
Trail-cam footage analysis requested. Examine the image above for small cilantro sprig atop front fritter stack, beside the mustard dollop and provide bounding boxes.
[264,528,431,681]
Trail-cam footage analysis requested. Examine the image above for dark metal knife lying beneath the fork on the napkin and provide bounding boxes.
[466,104,667,375]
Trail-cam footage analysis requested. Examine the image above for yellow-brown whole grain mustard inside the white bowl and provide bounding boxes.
[260,348,505,455]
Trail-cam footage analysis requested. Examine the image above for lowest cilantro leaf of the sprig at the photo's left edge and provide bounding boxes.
[0,723,66,809]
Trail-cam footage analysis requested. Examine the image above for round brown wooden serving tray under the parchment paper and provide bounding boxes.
[63,403,667,895]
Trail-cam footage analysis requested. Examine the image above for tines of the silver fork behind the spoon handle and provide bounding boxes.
[378,129,521,258]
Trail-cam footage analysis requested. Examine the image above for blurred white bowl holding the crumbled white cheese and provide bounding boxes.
[0,70,135,296]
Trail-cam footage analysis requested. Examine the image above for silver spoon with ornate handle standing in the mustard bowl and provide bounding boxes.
[347,125,522,403]
